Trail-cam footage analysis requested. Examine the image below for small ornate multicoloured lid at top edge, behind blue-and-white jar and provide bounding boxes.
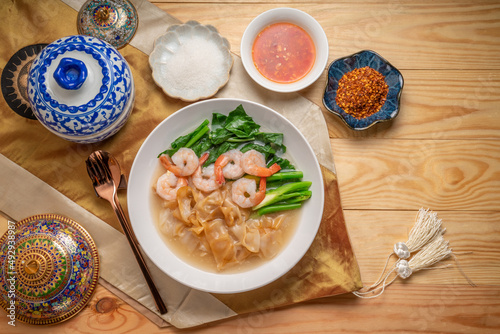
[77,0,139,49]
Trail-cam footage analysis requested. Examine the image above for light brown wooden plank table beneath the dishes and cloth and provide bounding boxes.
[2,0,500,333]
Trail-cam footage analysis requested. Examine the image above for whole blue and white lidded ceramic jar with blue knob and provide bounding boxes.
[28,35,135,143]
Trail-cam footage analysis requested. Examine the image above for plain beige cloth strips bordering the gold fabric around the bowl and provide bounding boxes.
[0,0,344,328]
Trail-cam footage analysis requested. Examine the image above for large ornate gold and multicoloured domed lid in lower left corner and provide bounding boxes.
[0,214,99,325]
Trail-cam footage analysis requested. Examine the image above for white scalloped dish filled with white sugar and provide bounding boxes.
[149,21,233,102]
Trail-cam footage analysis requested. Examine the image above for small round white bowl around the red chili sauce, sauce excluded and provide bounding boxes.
[240,8,328,93]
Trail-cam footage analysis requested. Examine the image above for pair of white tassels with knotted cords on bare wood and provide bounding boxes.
[353,209,475,298]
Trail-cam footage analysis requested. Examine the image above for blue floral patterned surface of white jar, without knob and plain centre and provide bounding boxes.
[28,35,134,142]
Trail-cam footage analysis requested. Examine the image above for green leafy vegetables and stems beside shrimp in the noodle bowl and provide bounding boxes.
[158,105,312,215]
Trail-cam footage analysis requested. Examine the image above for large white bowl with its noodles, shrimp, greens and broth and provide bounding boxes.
[127,99,324,293]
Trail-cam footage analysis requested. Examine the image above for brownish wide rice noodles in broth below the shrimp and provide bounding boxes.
[159,183,284,271]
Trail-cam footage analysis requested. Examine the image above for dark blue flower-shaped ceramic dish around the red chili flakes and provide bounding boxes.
[323,50,403,130]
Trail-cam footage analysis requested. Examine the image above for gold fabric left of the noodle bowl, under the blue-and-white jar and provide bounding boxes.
[0,0,187,230]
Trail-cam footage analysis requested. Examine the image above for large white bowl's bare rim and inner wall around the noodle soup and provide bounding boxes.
[127,99,324,293]
